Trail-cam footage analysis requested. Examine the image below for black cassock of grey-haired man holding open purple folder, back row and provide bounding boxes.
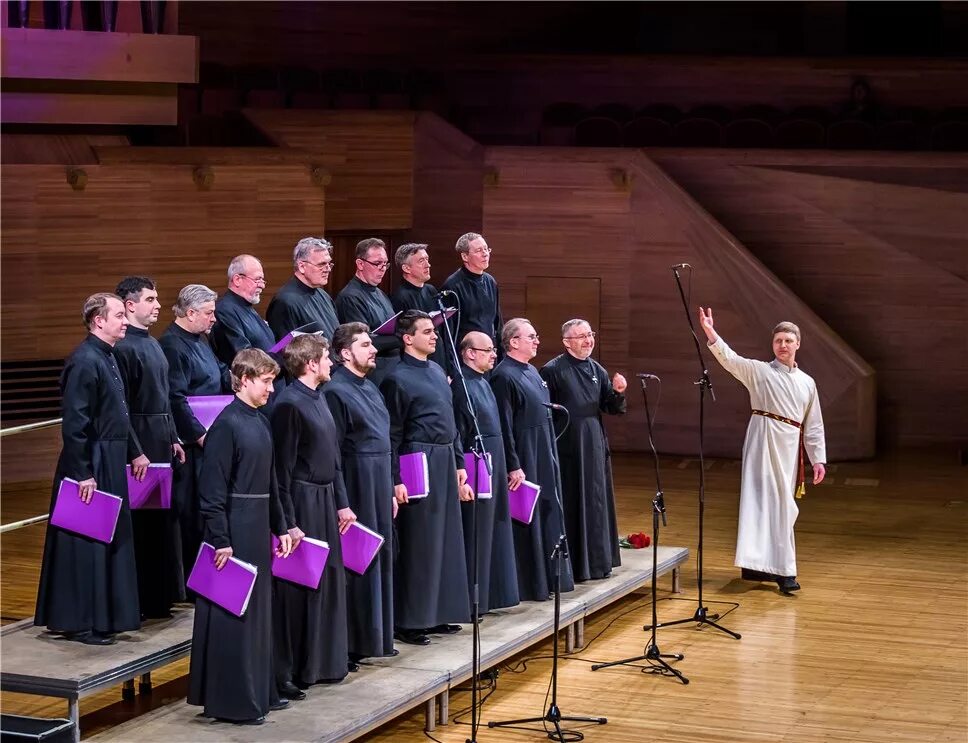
[158,323,231,578]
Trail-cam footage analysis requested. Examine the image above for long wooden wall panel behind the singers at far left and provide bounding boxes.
[0,163,325,360]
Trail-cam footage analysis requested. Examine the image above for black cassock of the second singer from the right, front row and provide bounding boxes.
[491,357,575,601]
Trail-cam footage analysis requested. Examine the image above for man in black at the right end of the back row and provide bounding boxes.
[442,232,503,376]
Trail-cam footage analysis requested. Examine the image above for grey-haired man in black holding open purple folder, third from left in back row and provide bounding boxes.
[158,284,232,571]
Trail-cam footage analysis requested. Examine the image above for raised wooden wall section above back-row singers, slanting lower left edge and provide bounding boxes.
[245,109,414,231]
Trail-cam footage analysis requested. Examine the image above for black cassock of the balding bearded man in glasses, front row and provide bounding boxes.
[451,365,519,613]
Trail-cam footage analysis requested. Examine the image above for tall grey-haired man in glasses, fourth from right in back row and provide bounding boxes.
[266,237,339,341]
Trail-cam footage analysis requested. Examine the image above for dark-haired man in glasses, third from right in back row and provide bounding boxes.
[336,237,400,387]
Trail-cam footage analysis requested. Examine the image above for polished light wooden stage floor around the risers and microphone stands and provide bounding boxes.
[0,452,968,743]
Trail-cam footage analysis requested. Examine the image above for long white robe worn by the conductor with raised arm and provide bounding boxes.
[709,338,827,576]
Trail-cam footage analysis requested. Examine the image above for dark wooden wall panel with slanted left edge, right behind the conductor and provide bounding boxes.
[654,150,968,444]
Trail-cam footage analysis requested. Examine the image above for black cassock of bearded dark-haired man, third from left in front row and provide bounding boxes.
[323,366,393,657]
